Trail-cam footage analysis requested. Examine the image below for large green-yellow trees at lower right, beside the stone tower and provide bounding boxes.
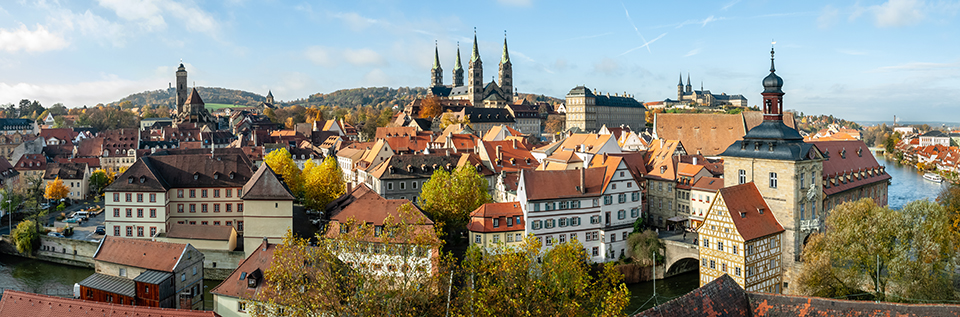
[797,198,958,301]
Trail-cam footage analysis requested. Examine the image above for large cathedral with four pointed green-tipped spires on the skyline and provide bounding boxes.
[428,31,514,108]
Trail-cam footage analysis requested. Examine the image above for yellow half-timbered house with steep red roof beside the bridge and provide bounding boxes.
[698,182,784,294]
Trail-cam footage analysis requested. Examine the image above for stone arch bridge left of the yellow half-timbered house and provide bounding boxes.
[656,231,700,279]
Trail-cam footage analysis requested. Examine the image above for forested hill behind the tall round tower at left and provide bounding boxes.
[110,87,266,108]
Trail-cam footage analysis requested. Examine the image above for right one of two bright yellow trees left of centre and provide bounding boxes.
[301,156,346,210]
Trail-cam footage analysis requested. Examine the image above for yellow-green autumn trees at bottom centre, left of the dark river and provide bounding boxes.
[456,235,629,317]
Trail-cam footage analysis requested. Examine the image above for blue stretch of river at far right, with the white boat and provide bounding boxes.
[876,155,947,209]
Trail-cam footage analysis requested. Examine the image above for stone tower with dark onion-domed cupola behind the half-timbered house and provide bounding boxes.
[720,50,825,294]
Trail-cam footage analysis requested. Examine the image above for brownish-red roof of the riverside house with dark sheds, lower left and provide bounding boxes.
[93,236,189,272]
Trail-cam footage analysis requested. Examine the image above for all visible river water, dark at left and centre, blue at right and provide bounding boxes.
[0,155,945,313]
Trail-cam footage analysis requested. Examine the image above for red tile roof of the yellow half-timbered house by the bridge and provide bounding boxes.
[710,182,783,241]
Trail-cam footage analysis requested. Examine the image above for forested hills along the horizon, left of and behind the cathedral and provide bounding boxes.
[109,87,563,108]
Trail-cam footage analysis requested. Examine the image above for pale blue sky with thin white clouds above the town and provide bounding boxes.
[0,0,960,121]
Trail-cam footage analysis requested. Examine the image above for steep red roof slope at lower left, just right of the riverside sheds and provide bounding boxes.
[210,242,277,299]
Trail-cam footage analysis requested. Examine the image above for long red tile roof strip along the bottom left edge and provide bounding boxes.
[0,290,220,317]
